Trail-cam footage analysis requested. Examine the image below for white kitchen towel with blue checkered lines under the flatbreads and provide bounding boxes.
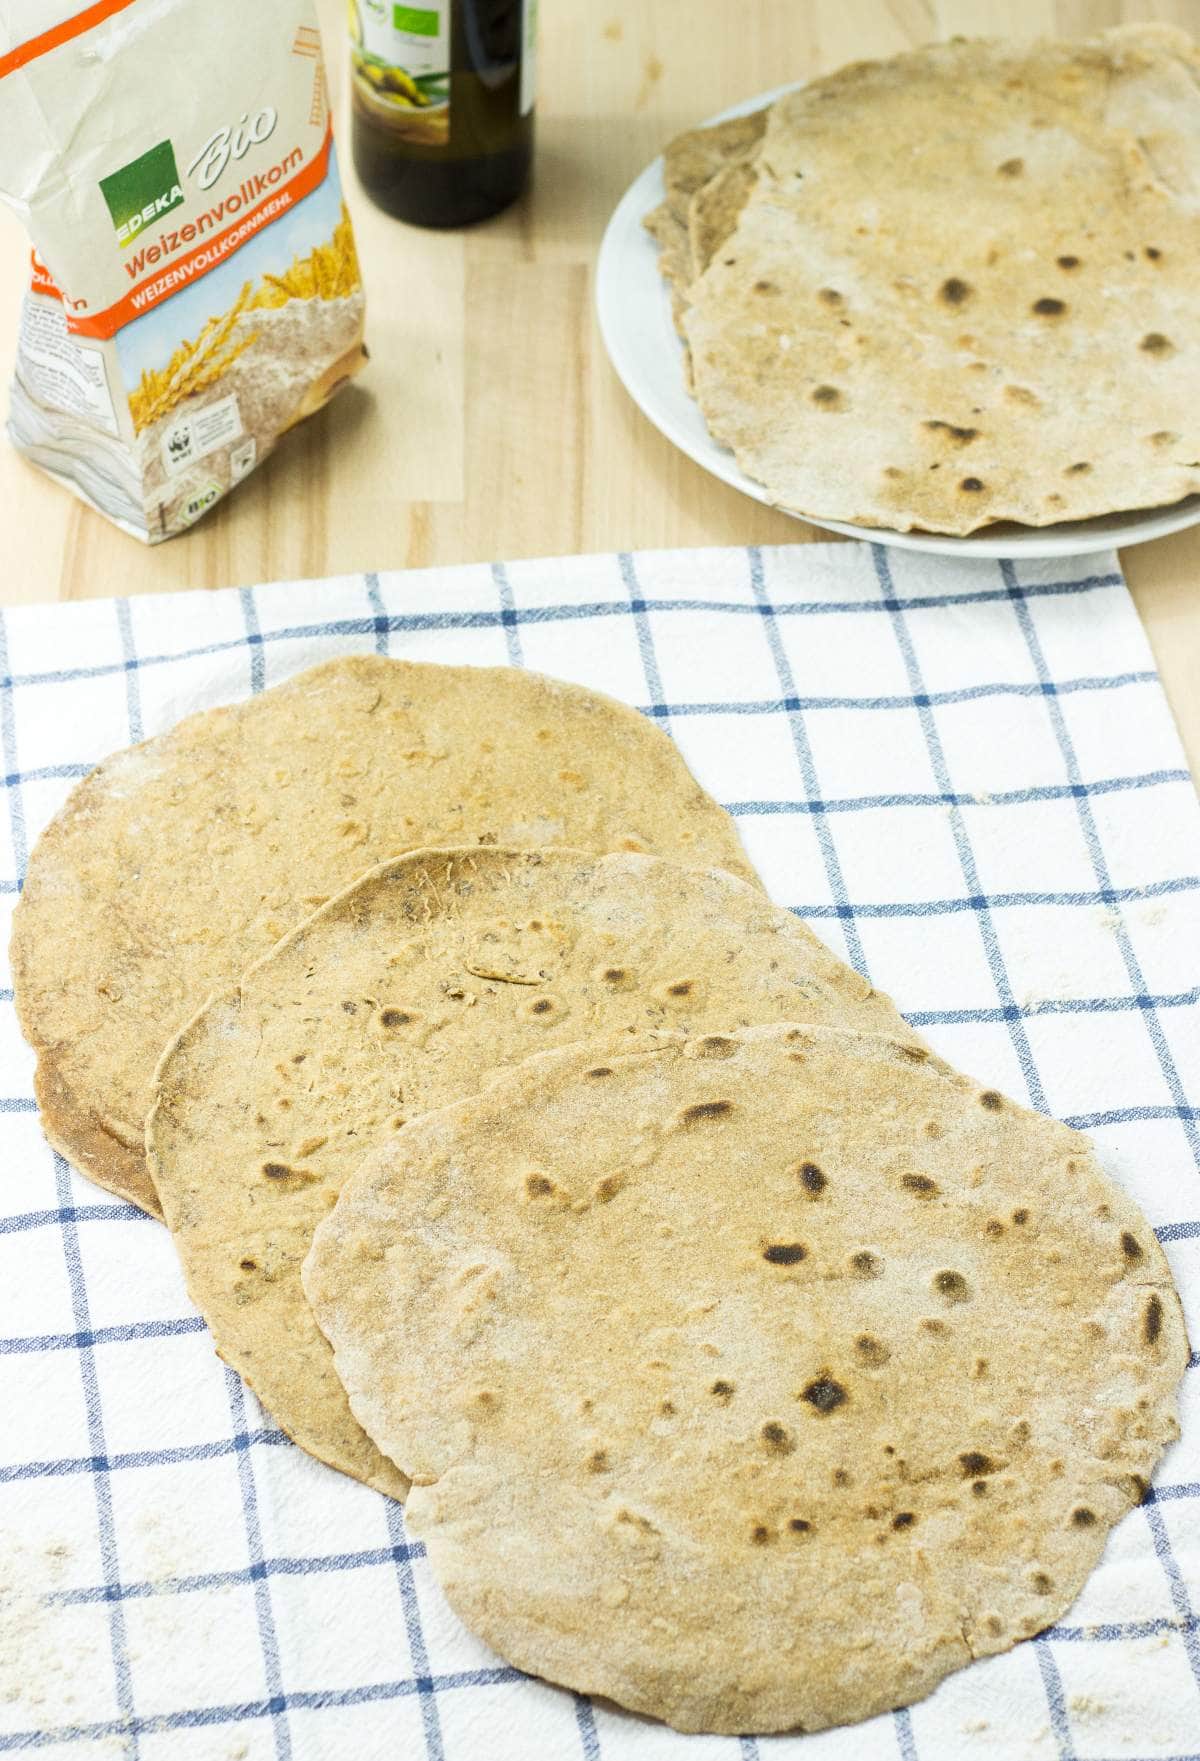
[0,544,1200,1761]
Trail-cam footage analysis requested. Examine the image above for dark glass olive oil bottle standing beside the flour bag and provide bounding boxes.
[349,0,537,227]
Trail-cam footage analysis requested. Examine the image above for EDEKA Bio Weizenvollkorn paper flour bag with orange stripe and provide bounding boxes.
[0,0,365,542]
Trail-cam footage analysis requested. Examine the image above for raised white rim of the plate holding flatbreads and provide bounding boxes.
[594,79,1200,562]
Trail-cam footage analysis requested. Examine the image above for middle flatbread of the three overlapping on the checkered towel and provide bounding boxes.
[146,849,925,1493]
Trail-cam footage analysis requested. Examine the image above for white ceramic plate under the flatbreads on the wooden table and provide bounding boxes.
[596,86,1200,556]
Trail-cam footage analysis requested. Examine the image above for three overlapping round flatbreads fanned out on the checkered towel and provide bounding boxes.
[12,641,1186,1731]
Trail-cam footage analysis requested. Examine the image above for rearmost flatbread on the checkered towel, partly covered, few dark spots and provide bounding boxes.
[12,655,752,1215]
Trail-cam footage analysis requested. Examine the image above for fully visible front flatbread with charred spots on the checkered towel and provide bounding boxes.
[305,1027,1188,1733]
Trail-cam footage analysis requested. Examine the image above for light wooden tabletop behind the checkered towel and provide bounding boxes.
[0,0,1200,775]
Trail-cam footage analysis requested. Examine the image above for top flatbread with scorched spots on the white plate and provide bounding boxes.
[684,25,1200,534]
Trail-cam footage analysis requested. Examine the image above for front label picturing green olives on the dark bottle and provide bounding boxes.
[349,0,451,146]
